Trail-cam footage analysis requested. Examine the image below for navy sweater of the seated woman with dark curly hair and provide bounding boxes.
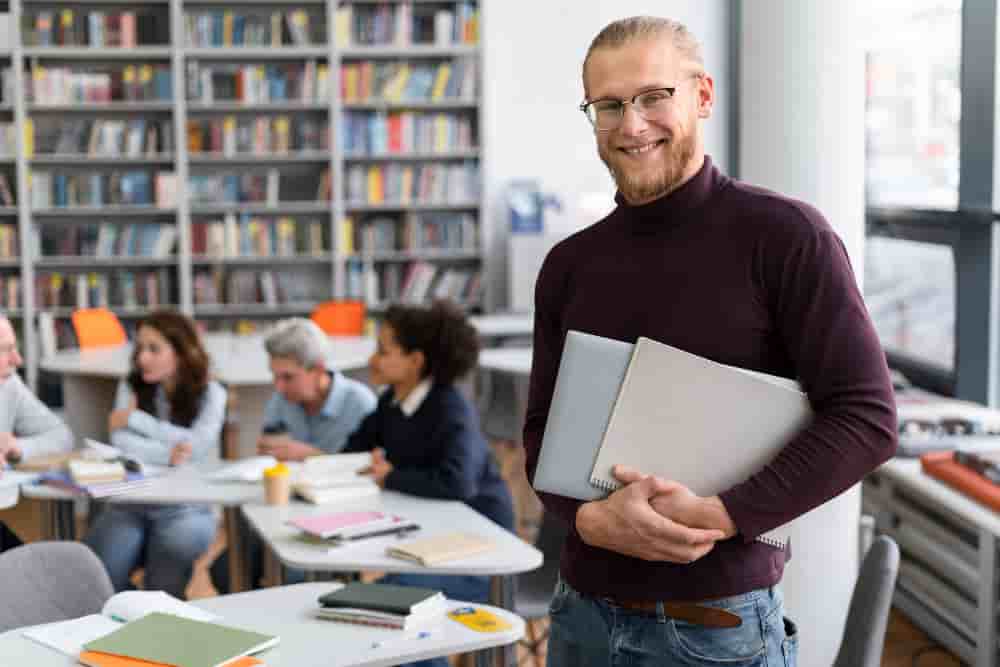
[344,384,514,531]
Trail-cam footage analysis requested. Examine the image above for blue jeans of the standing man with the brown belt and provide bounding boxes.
[546,579,798,667]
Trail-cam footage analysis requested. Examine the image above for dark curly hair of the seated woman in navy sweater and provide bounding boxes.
[385,300,479,384]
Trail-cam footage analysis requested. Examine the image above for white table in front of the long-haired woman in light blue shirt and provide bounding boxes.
[22,463,264,592]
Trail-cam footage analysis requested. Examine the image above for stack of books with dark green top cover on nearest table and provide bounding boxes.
[316,583,447,634]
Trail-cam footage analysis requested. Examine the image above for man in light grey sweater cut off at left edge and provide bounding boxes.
[0,313,73,551]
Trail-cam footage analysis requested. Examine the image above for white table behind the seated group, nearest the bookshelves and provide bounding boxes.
[41,333,375,456]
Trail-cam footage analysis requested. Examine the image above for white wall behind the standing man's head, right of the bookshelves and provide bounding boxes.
[482,0,730,306]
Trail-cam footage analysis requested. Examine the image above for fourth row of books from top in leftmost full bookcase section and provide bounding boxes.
[31,169,177,209]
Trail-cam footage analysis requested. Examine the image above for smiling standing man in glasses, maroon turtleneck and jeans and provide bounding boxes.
[524,17,896,667]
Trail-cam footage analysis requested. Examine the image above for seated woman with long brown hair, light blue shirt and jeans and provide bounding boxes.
[84,311,226,599]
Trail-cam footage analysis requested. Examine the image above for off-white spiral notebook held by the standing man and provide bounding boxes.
[590,338,812,546]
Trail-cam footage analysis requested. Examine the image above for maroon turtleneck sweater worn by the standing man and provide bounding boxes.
[524,157,896,600]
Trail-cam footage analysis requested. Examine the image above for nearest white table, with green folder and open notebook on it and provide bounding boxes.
[0,583,524,667]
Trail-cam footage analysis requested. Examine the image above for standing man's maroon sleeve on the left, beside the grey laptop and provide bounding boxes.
[523,246,583,527]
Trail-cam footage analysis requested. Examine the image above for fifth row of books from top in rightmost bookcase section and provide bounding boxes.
[346,213,479,252]
